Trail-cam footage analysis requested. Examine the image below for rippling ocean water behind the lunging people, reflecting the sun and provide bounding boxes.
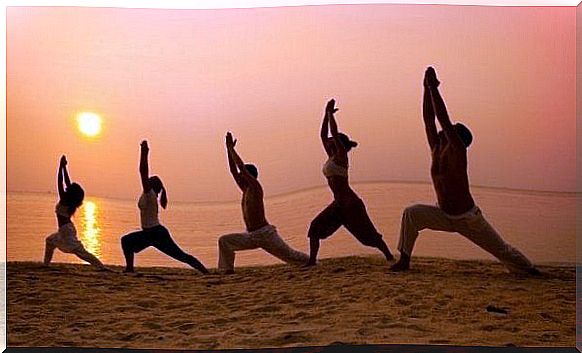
[7,183,576,267]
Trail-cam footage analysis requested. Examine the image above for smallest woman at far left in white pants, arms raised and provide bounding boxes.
[44,156,107,270]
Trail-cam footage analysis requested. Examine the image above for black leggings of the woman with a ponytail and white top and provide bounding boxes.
[121,225,208,273]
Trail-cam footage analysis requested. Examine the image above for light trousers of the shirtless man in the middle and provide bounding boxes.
[218,224,309,271]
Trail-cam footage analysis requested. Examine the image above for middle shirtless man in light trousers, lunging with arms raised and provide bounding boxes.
[218,132,309,274]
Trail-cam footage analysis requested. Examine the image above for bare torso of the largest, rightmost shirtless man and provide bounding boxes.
[430,140,475,215]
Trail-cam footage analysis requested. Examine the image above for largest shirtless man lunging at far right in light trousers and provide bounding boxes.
[391,67,540,275]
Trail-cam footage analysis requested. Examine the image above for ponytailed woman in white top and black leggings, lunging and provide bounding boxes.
[121,140,208,274]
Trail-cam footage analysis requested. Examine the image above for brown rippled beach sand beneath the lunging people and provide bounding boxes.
[7,256,576,349]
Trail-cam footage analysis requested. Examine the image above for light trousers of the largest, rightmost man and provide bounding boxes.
[398,204,533,272]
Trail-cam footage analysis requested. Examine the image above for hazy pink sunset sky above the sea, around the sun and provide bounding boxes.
[7,5,576,201]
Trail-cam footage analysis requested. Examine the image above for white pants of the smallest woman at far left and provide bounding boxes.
[44,223,104,268]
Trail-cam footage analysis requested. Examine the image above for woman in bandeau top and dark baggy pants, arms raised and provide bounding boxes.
[307,99,394,266]
